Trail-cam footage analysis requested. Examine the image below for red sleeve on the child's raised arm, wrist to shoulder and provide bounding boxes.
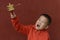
[11,17,32,34]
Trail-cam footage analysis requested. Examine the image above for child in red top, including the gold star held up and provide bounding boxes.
[8,4,51,40]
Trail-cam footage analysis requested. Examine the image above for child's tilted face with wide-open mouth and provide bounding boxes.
[35,16,48,30]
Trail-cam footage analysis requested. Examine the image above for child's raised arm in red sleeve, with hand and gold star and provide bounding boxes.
[7,3,32,34]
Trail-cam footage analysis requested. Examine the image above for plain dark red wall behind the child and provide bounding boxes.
[0,0,60,40]
